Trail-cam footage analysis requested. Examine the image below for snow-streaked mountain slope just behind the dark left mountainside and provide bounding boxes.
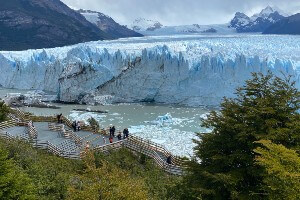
[78,9,143,38]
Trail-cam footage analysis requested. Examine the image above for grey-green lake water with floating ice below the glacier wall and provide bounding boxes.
[0,88,210,156]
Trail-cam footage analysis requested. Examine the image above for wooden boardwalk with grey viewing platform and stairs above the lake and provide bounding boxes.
[0,109,184,175]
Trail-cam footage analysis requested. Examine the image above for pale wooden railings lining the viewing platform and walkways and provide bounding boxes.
[6,109,184,175]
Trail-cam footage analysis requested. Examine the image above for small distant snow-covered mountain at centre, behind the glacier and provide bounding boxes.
[131,18,163,31]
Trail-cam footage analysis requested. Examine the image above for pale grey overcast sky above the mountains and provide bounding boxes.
[62,0,300,25]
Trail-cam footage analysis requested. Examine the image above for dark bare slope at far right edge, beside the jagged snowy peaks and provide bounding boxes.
[263,13,300,35]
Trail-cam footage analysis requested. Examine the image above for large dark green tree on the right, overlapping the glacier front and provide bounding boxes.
[182,73,300,199]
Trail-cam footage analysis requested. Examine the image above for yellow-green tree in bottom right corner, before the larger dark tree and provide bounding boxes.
[255,140,300,200]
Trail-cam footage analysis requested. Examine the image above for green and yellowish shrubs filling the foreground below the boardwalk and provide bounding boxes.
[0,139,178,200]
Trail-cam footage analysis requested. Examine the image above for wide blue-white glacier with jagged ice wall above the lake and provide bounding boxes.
[0,34,300,106]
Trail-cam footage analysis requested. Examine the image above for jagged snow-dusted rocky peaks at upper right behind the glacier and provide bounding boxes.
[229,6,288,33]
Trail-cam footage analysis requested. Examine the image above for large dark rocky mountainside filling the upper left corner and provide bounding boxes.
[0,0,112,50]
